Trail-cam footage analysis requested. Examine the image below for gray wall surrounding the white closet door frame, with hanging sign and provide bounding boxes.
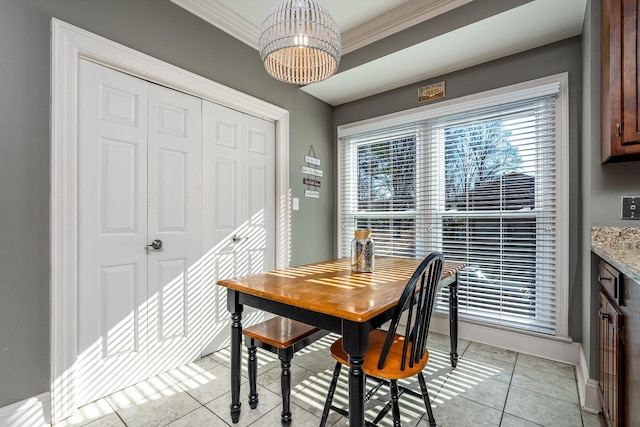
[0,0,334,408]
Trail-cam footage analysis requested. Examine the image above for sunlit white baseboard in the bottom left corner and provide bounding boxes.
[0,392,51,427]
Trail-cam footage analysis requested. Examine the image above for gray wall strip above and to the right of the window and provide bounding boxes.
[334,37,583,342]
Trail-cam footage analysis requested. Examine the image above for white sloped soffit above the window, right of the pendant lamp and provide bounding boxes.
[301,0,586,106]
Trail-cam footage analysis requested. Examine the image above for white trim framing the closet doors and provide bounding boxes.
[50,18,290,423]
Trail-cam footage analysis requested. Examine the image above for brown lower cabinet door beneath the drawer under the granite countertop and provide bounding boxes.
[598,292,624,427]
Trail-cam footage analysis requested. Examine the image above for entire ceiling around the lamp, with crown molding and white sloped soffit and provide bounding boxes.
[171,0,587,106]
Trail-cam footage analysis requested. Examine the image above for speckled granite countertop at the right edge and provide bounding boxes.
[591,227,640,283]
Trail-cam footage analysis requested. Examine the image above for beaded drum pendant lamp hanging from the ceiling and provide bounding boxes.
[259,0,342,85]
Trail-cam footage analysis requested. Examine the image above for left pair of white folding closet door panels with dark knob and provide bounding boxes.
[77,61,202,404]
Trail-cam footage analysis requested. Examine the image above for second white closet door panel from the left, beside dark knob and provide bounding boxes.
[147,84,206,375]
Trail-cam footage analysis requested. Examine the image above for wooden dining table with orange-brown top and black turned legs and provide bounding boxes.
[218,257,466,426]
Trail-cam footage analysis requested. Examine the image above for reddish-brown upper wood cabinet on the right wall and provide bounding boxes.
[601,0,640,163]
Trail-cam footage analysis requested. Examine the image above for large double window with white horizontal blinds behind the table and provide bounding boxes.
[338,76,568,336]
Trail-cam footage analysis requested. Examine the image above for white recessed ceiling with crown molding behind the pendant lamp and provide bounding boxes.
[171,0,473,55]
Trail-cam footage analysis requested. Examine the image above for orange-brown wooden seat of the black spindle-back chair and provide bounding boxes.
[331,329,429,380]
